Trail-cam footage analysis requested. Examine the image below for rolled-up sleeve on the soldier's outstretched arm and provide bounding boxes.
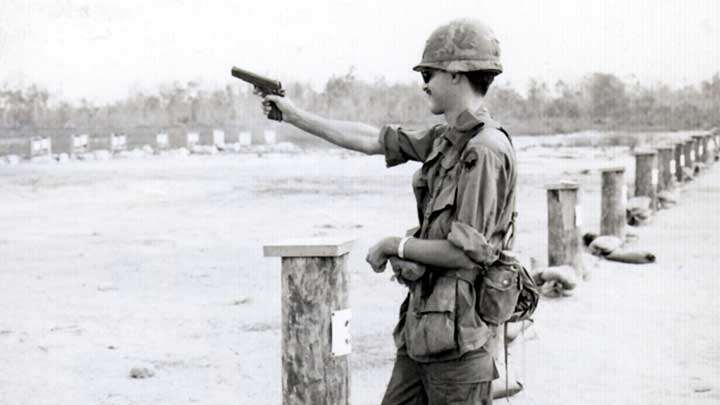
[379,124,442,167]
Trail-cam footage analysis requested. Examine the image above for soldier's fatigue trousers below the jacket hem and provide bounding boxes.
[382,350,497,405]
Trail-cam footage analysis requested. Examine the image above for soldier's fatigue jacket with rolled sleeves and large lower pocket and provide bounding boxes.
[379,109,517,366]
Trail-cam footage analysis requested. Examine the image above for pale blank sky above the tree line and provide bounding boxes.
[0,0,720,102]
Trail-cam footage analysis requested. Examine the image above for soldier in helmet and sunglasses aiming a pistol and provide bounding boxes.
[263,19,516,405]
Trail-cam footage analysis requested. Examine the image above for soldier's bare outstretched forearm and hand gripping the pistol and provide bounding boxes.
[263,95,383,155]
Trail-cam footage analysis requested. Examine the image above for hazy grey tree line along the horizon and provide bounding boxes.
[0,69,720,138]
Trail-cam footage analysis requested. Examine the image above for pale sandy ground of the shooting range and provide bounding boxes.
[0,139,720,405]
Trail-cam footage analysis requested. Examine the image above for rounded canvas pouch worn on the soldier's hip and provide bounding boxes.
[475,251,523,325]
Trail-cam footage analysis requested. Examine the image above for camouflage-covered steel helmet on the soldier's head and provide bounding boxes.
[413,18,502,74]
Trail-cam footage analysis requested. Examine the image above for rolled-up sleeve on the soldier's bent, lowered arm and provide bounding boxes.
[448,147,509,265]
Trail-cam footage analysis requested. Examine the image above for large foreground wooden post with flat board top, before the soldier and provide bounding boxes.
[263,239,352,405]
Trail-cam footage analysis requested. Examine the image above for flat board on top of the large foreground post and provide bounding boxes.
[263,238,354,257]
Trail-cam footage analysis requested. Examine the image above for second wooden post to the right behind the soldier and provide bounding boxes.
[600,166,627,240]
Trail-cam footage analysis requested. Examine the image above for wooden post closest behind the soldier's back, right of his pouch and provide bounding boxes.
[545,182,585,276]
